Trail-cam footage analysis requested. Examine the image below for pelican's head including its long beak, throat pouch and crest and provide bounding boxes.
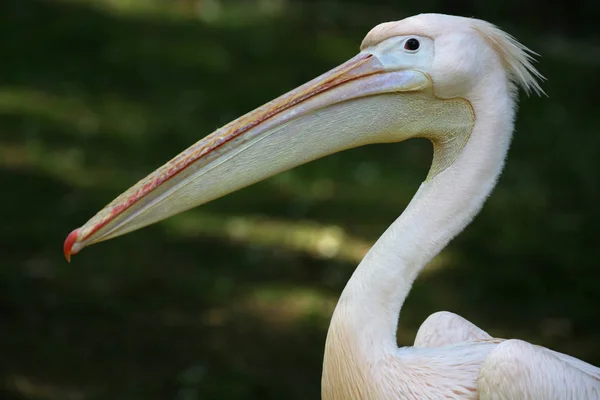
[64,14,540,259]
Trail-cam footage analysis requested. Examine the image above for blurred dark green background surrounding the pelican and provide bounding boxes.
[0,0,600,400]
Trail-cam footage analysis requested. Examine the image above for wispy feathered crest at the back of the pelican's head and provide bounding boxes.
[473,20,546,95]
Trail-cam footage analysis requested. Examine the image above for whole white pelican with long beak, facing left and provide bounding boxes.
[64,14,600,400]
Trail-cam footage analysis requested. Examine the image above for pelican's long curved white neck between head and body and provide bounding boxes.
[323,86,514,397]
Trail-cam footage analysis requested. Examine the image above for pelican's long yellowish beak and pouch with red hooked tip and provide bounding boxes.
[64,51,450,260]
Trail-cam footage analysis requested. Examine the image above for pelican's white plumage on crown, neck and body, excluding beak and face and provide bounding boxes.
[322,14,600,400]
